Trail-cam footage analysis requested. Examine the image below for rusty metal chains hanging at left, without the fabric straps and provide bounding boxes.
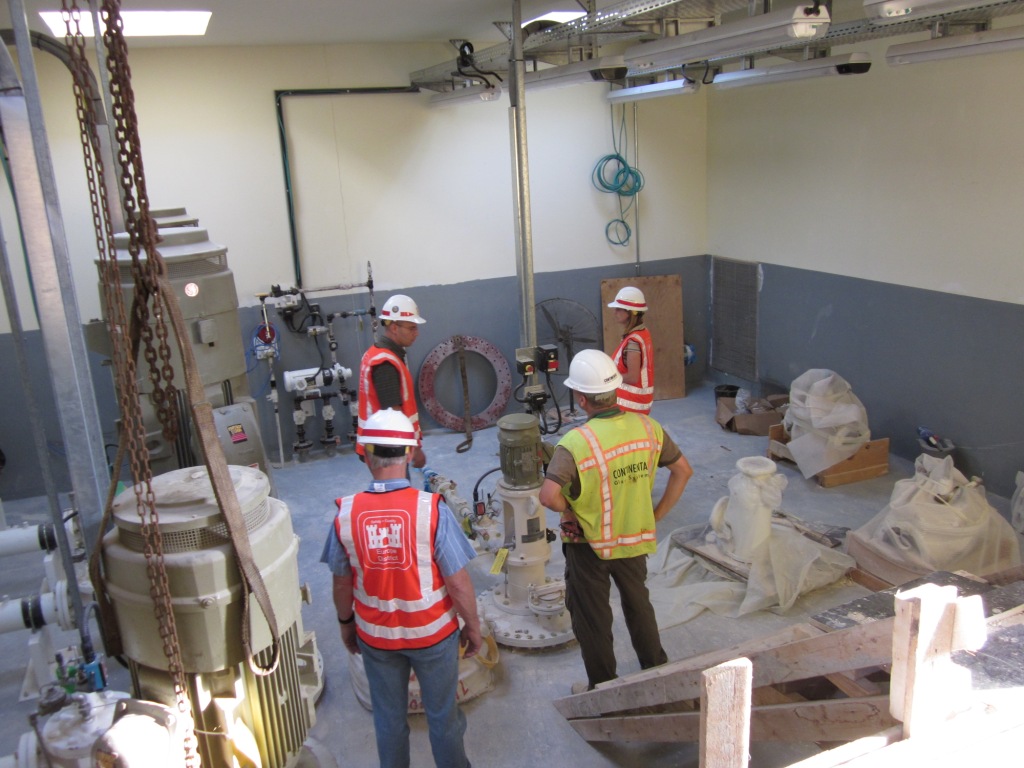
[61,0,200,768]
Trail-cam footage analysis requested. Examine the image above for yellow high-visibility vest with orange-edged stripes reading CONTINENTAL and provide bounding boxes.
[560,415,662,560]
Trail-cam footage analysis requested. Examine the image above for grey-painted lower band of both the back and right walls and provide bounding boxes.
[6,256,1024,499]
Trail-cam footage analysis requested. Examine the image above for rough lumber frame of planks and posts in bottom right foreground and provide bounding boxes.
[554,572,1024,768]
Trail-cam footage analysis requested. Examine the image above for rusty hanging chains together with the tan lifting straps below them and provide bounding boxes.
[61,0,281,768]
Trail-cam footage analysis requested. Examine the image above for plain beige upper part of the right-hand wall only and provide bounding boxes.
[708,32,1024,303]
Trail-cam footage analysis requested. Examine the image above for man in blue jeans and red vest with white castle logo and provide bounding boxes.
[321,409,482,768]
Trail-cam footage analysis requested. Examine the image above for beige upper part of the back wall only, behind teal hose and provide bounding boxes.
[0,44,707,331]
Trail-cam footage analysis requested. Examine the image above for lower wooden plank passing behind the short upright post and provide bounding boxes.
[569,696,896,742]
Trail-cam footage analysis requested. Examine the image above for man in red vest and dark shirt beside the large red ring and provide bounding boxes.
[355,294,427,469]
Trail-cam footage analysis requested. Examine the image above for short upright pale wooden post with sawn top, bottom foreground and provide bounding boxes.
[698,658,754,768]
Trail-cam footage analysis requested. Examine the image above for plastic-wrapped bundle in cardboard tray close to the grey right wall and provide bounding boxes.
[782,368,871,477]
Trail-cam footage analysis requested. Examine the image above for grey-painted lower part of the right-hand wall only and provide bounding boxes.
[758,264,1024,497]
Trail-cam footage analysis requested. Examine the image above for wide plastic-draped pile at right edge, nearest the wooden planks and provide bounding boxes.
[852,454,1021,575]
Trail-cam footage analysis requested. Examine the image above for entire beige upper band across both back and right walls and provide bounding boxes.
[9,10,1024,331]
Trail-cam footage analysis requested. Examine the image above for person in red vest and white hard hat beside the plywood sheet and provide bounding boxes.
[608,286,654,414]
